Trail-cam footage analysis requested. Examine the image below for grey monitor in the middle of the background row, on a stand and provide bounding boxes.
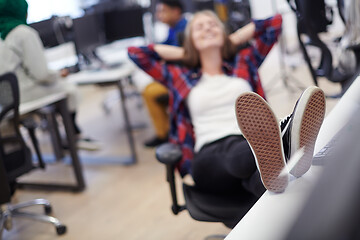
[73,14,104,60]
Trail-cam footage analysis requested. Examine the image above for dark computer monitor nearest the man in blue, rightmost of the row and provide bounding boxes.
[104,8,145,43]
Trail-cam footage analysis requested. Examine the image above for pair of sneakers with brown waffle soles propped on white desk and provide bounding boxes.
[236,87,325,192]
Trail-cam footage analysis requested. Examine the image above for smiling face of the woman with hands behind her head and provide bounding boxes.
[191,14,224,51]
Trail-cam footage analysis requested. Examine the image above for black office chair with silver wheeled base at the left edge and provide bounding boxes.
[0,73,66,239]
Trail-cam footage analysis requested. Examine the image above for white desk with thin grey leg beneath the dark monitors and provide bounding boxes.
[67,61,137,165]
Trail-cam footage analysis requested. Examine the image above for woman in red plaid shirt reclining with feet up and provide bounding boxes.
[128,10,322,197]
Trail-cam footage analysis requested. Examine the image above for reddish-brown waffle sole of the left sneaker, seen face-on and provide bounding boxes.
[235,92,289,193]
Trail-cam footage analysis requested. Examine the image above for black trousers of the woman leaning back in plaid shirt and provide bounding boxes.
[192,135,265,196]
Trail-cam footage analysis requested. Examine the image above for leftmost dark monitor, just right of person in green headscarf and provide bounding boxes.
[29,18,59,48]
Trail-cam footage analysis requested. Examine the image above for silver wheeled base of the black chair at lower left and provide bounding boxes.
[0,198,66,240]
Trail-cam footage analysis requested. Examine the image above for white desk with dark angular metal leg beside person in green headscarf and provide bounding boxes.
[19,85,85,191]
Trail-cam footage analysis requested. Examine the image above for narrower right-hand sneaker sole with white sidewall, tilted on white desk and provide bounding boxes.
[290,87,325,177]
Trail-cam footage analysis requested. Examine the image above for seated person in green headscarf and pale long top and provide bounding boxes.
[0,0,98,150]
